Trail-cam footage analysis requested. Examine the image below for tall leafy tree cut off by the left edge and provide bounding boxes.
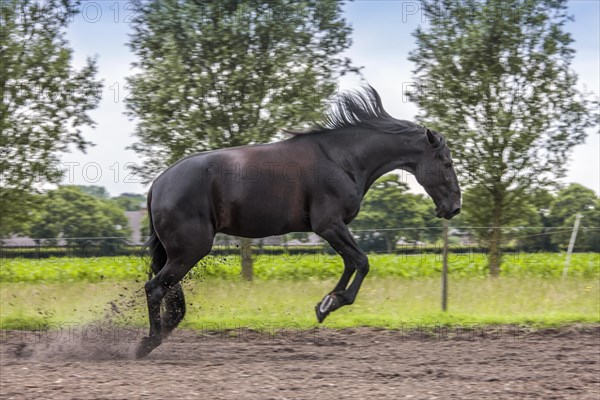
[0,0,101,235]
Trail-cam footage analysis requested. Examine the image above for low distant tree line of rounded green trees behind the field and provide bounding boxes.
[3,180,600,253]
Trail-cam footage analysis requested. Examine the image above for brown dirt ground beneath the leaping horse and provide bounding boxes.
[0,325,600,400]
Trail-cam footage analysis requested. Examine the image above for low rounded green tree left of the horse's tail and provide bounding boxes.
[29,186,131,247]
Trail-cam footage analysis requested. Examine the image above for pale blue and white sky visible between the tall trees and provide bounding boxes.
[61,0,600,196]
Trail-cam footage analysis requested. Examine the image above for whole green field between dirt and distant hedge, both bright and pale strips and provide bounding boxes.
[0,253,600,329]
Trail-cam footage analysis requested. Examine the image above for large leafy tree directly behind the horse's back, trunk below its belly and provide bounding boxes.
[127,0,356,276]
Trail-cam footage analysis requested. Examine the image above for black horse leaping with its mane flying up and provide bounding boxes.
[137,87,461,357]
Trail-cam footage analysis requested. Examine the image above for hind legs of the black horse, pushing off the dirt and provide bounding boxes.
[136,221,214,358]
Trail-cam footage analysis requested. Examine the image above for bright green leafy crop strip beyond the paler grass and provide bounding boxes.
[0,252,600,283]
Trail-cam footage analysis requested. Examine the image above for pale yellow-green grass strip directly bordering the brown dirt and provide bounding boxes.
[0,276,600,329]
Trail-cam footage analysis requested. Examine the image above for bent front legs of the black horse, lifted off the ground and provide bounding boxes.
[316,222,369,322]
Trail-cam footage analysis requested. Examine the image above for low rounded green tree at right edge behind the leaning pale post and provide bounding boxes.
[548,183,600,252]
